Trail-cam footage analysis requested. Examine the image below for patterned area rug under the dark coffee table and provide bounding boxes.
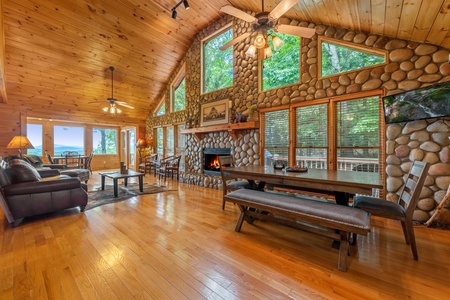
[86,183,168,210]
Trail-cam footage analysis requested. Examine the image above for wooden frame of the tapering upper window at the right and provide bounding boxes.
[317,36,389,79]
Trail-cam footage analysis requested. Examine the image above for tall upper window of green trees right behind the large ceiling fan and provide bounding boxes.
[262,31,300,91]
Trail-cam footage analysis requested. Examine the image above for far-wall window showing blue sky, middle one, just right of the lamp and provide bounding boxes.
[53,125,84,156]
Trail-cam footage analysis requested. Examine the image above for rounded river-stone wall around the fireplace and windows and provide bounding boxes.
[147,16,450,220]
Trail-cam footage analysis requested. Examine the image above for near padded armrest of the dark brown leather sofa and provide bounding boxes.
[4,178,81,196]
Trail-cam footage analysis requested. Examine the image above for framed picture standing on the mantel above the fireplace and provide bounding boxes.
[200,99,230,127]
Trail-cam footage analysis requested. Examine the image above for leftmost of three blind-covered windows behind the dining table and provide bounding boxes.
[263,109,289,166]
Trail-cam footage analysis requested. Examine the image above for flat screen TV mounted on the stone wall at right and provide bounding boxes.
[383,81,450,124]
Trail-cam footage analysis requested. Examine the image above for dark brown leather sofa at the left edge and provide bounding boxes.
[0,159,88,227]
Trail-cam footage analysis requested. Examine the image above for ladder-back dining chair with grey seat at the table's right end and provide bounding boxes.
[353,161,430,260]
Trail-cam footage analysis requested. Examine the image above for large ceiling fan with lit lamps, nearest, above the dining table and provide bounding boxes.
[219,0,316,58]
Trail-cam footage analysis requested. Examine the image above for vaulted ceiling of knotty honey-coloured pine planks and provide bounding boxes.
[0,0,450,120]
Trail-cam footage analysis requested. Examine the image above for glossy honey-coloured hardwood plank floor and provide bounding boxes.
[0,172,450,300]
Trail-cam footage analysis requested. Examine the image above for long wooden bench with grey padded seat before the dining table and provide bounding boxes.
[224,189,370,272]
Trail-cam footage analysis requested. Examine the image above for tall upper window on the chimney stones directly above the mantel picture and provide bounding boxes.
[202,27,233,93]
